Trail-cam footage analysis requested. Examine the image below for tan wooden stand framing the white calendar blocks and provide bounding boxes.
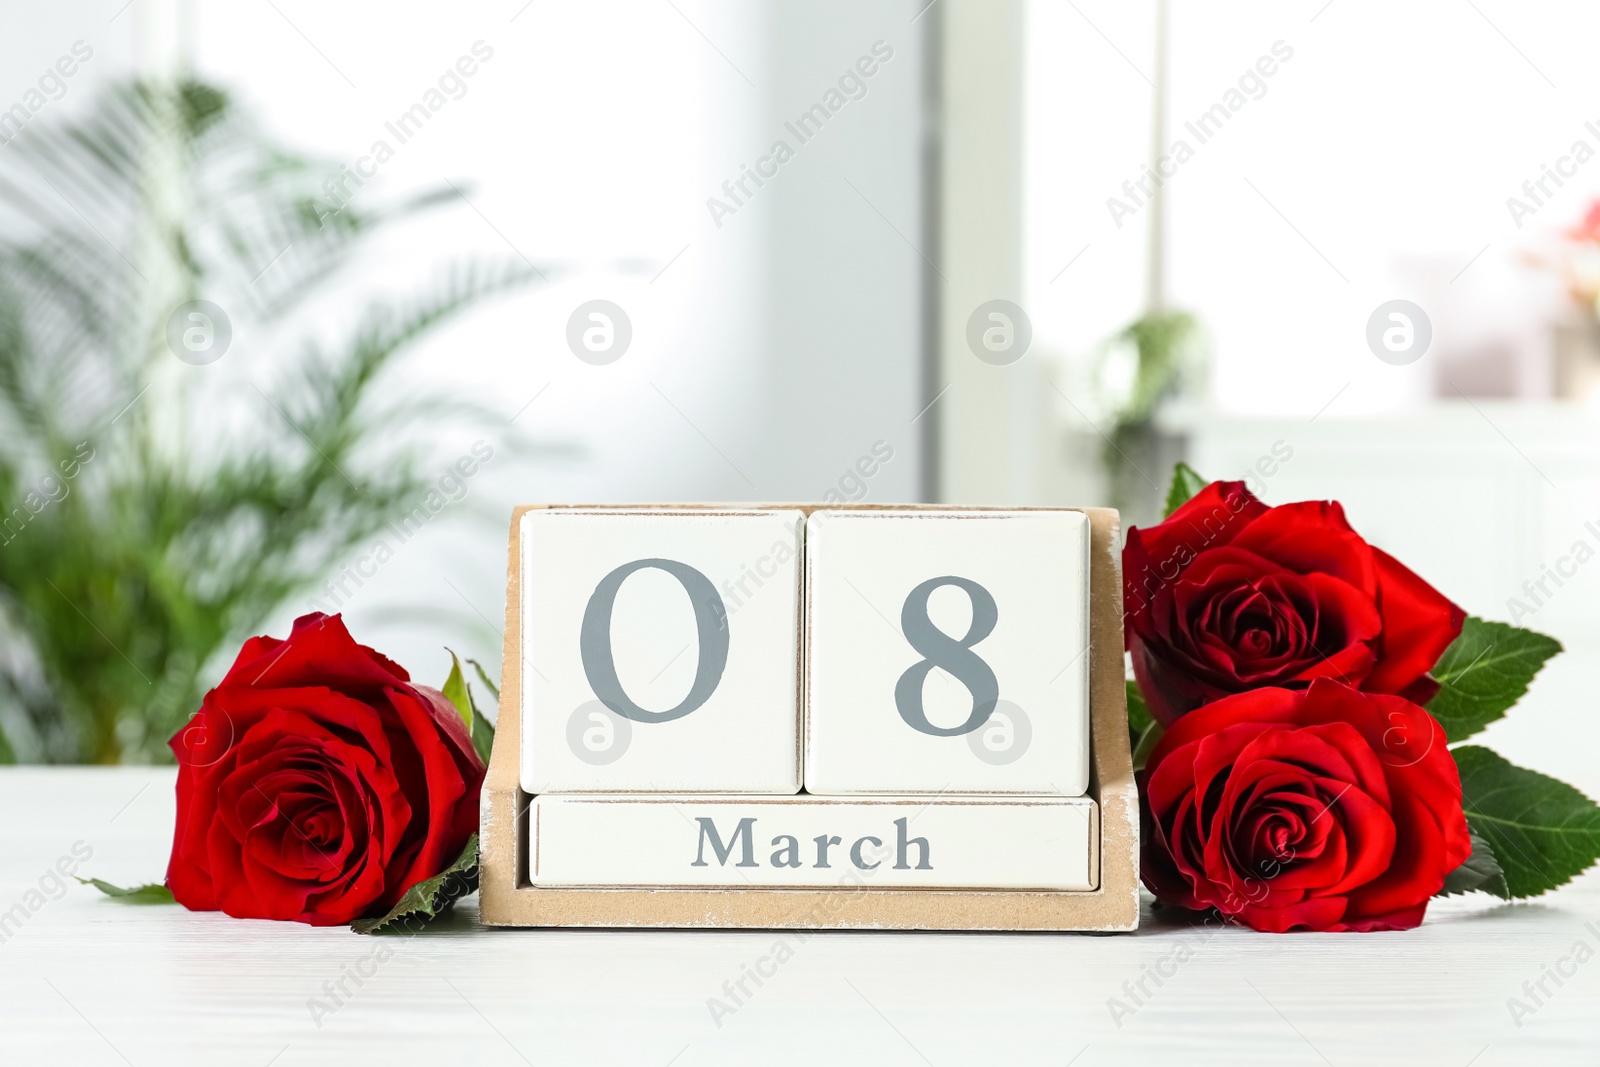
[480,504,1139,933]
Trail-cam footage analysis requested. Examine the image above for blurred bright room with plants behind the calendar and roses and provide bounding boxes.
[0,0,1600,793]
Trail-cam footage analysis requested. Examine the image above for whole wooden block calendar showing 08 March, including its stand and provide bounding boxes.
[480,504,1138,931]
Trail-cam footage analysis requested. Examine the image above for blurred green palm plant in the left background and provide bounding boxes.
[0,82,536,763]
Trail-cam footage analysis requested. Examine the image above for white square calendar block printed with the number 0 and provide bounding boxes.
[522,509,805,793]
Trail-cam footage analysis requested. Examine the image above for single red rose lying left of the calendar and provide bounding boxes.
[166,614,483,926]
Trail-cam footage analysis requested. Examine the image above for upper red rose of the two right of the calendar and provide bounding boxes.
[1122,482,1466,726]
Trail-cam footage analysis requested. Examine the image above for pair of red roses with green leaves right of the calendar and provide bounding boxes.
[1123,464,1600,931]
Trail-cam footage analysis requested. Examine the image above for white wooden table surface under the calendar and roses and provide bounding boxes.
[0,768,1600,1067]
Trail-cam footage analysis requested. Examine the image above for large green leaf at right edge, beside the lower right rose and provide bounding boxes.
[1451,745,1600,897]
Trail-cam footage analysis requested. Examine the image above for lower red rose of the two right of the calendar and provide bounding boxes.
[1139,678,1472,933]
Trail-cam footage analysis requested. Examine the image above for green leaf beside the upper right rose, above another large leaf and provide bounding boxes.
[1427,616,1562,744]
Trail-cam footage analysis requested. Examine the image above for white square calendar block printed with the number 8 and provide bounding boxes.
[805,510,1090,797]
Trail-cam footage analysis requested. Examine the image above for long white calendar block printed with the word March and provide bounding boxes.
[528,795,1099,891]
